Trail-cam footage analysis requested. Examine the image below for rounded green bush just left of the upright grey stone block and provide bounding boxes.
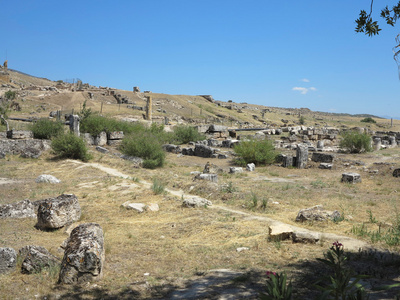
[234,140,277,165]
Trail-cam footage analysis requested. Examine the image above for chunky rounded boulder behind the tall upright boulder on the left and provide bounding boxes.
[36,194,81,229]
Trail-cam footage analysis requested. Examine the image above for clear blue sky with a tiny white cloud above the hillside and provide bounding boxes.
[0,0,400,117]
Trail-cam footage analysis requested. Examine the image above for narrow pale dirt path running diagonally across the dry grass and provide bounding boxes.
[68,160,372,251]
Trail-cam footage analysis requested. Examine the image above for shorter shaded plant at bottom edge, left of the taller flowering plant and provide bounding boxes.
[261,271,292,300]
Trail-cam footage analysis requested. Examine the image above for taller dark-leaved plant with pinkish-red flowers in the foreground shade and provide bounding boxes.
[316,241,367,300]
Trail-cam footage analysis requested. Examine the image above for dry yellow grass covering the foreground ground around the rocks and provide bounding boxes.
[0,145,399,299]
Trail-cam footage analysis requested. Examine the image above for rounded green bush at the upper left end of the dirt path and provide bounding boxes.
[51,133,92,161]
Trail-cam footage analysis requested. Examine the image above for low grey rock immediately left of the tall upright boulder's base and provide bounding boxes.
[18,245,60,274]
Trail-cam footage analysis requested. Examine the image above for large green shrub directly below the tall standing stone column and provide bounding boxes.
[120,131,165,169]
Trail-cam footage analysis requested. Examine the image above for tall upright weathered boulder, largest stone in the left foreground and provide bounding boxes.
[58,223,105,284]
